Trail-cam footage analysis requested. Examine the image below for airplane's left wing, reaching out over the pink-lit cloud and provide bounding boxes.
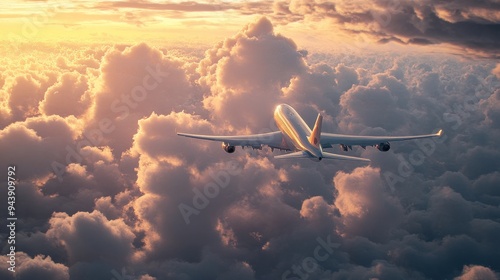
[177,131,290,150]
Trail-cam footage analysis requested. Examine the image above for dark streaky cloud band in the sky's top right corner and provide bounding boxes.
[275,0,500,58]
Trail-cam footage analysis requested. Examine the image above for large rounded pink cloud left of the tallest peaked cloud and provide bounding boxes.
[87,41,193,155]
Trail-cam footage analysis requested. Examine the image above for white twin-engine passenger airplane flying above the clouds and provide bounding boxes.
[177,104,443,162]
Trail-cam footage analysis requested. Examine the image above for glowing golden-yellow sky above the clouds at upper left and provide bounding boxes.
[0,0,262,44]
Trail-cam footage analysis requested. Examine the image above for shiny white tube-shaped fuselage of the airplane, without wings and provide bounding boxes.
[274,104,323,160]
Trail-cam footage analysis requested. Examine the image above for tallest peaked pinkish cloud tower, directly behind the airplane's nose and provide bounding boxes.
[198,17,306,130]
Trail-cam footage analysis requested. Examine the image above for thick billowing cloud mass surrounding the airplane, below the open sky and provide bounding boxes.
[0,17,500,280]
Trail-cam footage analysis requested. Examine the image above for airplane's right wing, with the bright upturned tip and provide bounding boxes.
[320,129,443,150]
